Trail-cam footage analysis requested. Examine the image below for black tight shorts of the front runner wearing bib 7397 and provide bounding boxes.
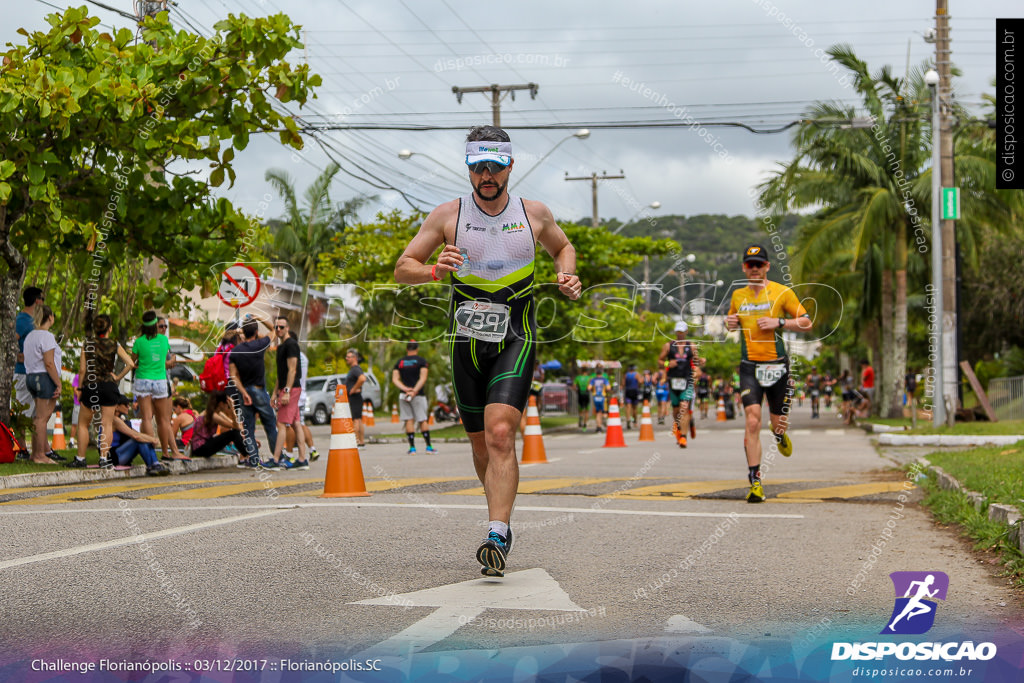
[450,335,537,433]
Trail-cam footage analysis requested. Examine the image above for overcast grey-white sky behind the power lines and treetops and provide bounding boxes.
[6,0,1024,220]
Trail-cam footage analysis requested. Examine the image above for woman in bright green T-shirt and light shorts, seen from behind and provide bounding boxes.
[131,310,173,458]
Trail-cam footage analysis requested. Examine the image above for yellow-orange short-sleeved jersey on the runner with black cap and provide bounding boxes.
[729,280,807,360]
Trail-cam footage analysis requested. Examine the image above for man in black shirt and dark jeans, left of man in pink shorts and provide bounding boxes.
[228,316,278,466]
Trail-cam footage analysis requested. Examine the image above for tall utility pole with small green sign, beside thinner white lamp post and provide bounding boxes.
[932,0,959,424]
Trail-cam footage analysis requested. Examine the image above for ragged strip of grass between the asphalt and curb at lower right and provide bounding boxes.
[921,454,1024,588]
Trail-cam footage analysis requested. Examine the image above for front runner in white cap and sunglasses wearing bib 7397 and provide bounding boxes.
[394,126,582,577]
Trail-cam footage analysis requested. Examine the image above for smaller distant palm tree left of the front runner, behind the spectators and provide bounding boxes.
[265,162,368,339]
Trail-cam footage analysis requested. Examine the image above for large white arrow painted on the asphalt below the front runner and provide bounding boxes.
[349,568,586,656]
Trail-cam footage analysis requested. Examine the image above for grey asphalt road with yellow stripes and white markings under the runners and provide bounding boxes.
[0,403,1022,671]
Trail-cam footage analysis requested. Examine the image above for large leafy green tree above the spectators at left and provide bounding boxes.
[0,7,319,418]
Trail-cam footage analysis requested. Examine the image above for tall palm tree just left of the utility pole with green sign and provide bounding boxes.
[760,45,931,414]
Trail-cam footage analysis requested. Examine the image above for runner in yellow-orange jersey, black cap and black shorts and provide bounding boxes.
[725,245,812,503]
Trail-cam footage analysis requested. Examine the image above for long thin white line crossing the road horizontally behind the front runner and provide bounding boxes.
[0,501,804,520]
